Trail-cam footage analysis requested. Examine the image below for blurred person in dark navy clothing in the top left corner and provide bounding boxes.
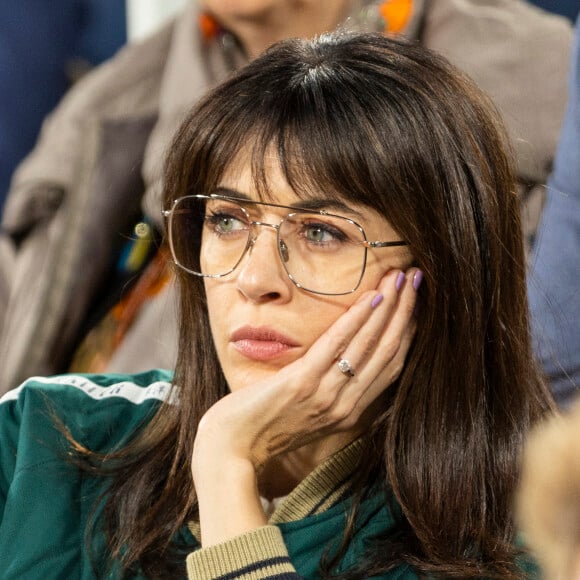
[0,0,126,213]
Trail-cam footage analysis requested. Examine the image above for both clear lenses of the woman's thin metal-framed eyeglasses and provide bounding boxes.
[170,196,366,294]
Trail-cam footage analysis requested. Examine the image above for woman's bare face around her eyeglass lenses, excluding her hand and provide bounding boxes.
[202,157,412,390]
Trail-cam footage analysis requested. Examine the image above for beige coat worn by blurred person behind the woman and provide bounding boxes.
[0,0,571,393]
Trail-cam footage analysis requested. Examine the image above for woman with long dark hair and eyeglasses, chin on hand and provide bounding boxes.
[0,35,552,578]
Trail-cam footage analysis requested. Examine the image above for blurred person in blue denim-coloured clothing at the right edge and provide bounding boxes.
[528,19,580,406]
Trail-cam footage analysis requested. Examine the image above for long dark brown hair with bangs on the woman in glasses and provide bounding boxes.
[89,34,552,578]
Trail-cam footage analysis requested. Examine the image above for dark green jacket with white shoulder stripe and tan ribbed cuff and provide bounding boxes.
[0,370,417,580]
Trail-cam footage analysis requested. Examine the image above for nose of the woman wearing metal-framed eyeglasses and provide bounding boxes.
[237,224,294,303]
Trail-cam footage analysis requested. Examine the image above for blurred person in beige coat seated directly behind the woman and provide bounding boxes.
[0,0,571,398]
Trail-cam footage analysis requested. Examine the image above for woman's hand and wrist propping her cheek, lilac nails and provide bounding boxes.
[192,269,421,545]
